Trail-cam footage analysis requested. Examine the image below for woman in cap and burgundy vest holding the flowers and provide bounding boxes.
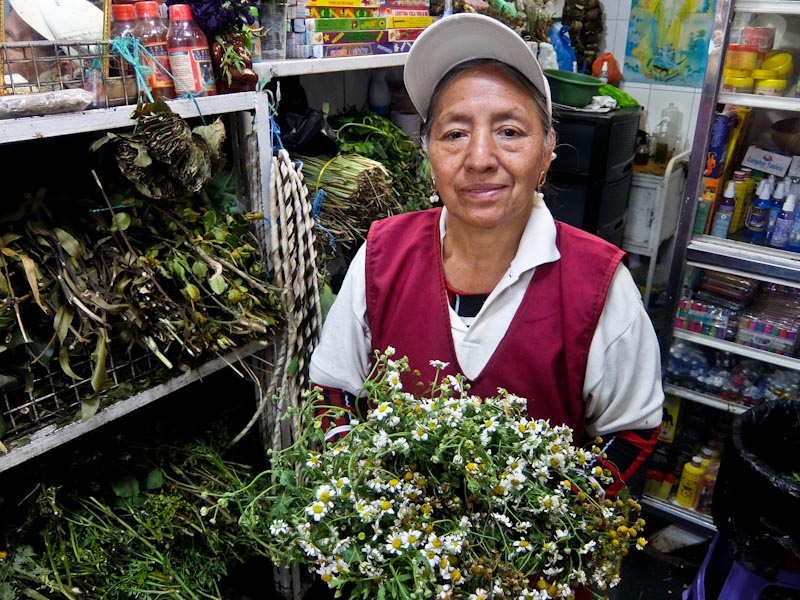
[310,14,663,500]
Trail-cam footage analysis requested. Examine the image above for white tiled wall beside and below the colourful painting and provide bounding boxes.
[601,0,700,157]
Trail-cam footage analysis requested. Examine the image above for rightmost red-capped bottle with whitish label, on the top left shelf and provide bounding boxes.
[167,4,217,96]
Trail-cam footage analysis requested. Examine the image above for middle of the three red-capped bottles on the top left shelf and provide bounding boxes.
[134,0,175,100]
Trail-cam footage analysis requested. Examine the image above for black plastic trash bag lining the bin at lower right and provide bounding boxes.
[711,400,800,580]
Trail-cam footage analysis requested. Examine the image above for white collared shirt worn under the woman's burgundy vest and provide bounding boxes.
[309,205,664,436]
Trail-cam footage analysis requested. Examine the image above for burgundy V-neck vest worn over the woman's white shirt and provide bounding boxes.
[366,209,624,443]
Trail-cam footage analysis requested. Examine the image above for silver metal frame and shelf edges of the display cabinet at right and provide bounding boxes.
[656,0,800,531]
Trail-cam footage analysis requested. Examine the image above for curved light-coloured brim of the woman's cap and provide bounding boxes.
[403,13,552,119]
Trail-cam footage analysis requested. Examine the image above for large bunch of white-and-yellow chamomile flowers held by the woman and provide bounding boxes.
[220,348,646,600]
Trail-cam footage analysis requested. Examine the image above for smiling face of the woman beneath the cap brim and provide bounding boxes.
[428,66,554,229]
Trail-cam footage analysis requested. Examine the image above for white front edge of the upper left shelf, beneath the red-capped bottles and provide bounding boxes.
[0,92,258,144]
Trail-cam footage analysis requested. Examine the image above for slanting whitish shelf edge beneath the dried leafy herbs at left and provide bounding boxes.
[0,342,269,473]
